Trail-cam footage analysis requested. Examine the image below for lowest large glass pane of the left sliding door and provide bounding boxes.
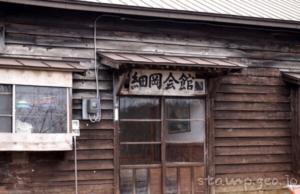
[120,144,161,164]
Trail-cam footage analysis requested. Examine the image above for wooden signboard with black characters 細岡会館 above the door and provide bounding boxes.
[129,69,205,96]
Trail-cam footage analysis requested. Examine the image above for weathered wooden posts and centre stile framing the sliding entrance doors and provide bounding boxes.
[113,73,216,194]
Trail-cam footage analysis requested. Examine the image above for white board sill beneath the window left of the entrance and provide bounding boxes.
[0,133,73,151]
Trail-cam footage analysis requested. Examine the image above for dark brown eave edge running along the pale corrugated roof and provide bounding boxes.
[0,0,300,29]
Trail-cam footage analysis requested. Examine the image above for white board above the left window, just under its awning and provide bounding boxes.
[0,69,72,88]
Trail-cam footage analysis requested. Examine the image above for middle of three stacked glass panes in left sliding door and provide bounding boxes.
[120,122,161,142]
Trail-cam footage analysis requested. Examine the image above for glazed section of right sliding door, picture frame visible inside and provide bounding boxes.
[165,98,205,162]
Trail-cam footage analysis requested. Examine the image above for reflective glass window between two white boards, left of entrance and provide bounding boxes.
[0,85,69,133]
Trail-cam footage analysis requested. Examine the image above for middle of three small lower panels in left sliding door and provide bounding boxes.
[135,169,148,194]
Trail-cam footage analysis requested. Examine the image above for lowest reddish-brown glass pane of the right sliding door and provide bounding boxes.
[166,144,204,162]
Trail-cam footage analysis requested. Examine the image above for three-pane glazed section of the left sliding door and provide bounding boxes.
[120,97,161,164]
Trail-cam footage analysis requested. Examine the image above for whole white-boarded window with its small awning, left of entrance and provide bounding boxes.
[0,61,79,151]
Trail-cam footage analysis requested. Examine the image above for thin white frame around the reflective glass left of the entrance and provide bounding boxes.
[0,83,72,136]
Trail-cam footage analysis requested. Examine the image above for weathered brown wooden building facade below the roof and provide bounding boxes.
[0,1,300,194]
